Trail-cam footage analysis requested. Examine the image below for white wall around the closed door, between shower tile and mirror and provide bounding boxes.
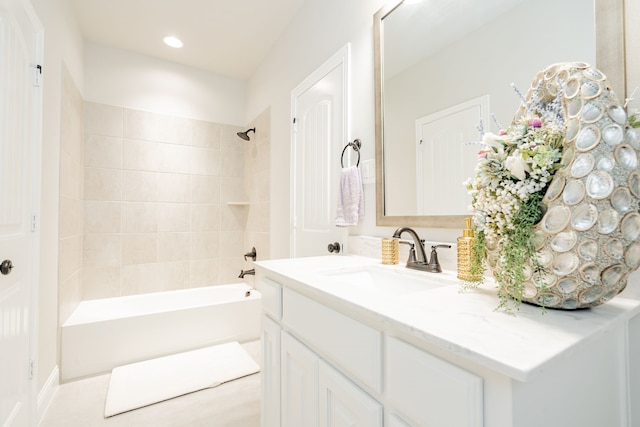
[246,0,386,258]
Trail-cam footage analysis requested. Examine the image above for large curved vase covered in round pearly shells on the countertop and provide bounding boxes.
[488,63,640,310]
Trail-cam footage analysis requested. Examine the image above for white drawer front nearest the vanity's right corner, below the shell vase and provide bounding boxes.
[385,337,483,427]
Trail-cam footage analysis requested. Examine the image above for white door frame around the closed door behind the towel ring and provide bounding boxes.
[289,43,351,257]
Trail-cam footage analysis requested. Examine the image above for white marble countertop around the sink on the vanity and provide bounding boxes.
[255,255,640,381]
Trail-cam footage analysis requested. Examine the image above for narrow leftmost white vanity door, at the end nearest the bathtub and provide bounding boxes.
[261,314,280,427]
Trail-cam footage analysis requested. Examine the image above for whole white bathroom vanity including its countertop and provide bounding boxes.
[256,257,640,427]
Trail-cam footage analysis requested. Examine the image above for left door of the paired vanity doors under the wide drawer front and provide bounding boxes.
[281,331,319,427]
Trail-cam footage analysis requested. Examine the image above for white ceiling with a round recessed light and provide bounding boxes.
[71,0,305,79]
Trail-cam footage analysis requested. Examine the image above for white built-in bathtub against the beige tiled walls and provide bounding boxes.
[60,283,261,381]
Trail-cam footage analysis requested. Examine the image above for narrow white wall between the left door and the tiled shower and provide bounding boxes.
[31,0,83,396]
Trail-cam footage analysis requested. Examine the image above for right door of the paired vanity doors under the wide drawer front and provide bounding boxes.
[319,360,382,427]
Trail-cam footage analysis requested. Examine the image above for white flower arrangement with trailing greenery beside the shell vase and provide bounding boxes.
[465,88,566,312]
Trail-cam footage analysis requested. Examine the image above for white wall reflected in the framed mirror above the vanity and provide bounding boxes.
[385,0,596,215]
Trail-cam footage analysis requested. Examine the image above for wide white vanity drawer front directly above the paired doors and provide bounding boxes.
[282,289,382,391]
